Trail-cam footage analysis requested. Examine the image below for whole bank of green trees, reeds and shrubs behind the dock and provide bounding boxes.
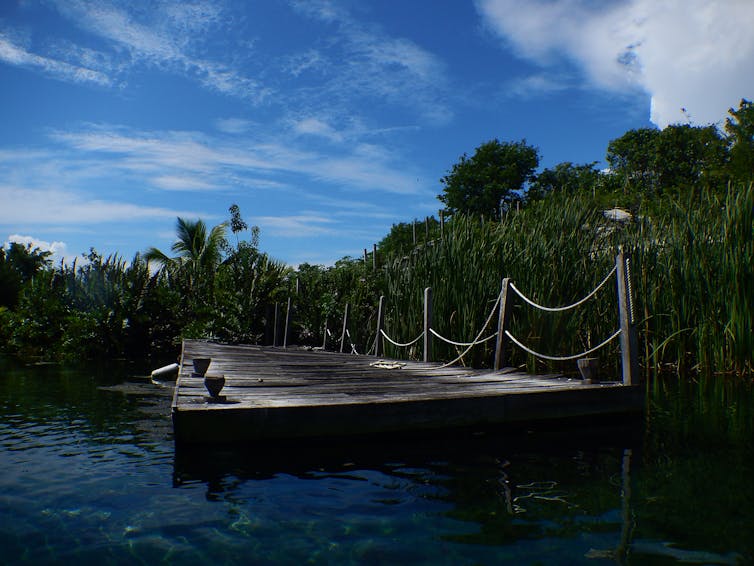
[0,100,754,378]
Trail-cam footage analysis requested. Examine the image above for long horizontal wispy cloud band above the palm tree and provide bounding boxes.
[48,121,420,194]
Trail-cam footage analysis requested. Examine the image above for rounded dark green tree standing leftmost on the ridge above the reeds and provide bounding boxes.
[438,139,539,222]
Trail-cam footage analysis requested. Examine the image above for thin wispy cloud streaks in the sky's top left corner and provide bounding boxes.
[0,0,272,103]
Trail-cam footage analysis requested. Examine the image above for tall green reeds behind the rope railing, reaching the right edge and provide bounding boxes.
[384,185,754,375]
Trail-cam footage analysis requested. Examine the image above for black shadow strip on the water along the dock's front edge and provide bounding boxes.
[174,416,643,486]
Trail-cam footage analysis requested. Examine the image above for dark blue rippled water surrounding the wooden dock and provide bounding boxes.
[0,359,754,565]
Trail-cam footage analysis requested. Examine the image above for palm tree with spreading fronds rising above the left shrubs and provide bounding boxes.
[144,218,227,291]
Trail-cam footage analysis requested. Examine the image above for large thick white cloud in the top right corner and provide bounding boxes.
[476,0,754,127]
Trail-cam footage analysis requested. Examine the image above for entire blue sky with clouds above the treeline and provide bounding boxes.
[0,0,754,265]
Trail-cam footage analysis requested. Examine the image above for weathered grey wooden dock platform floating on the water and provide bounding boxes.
[172,340,644,444]
